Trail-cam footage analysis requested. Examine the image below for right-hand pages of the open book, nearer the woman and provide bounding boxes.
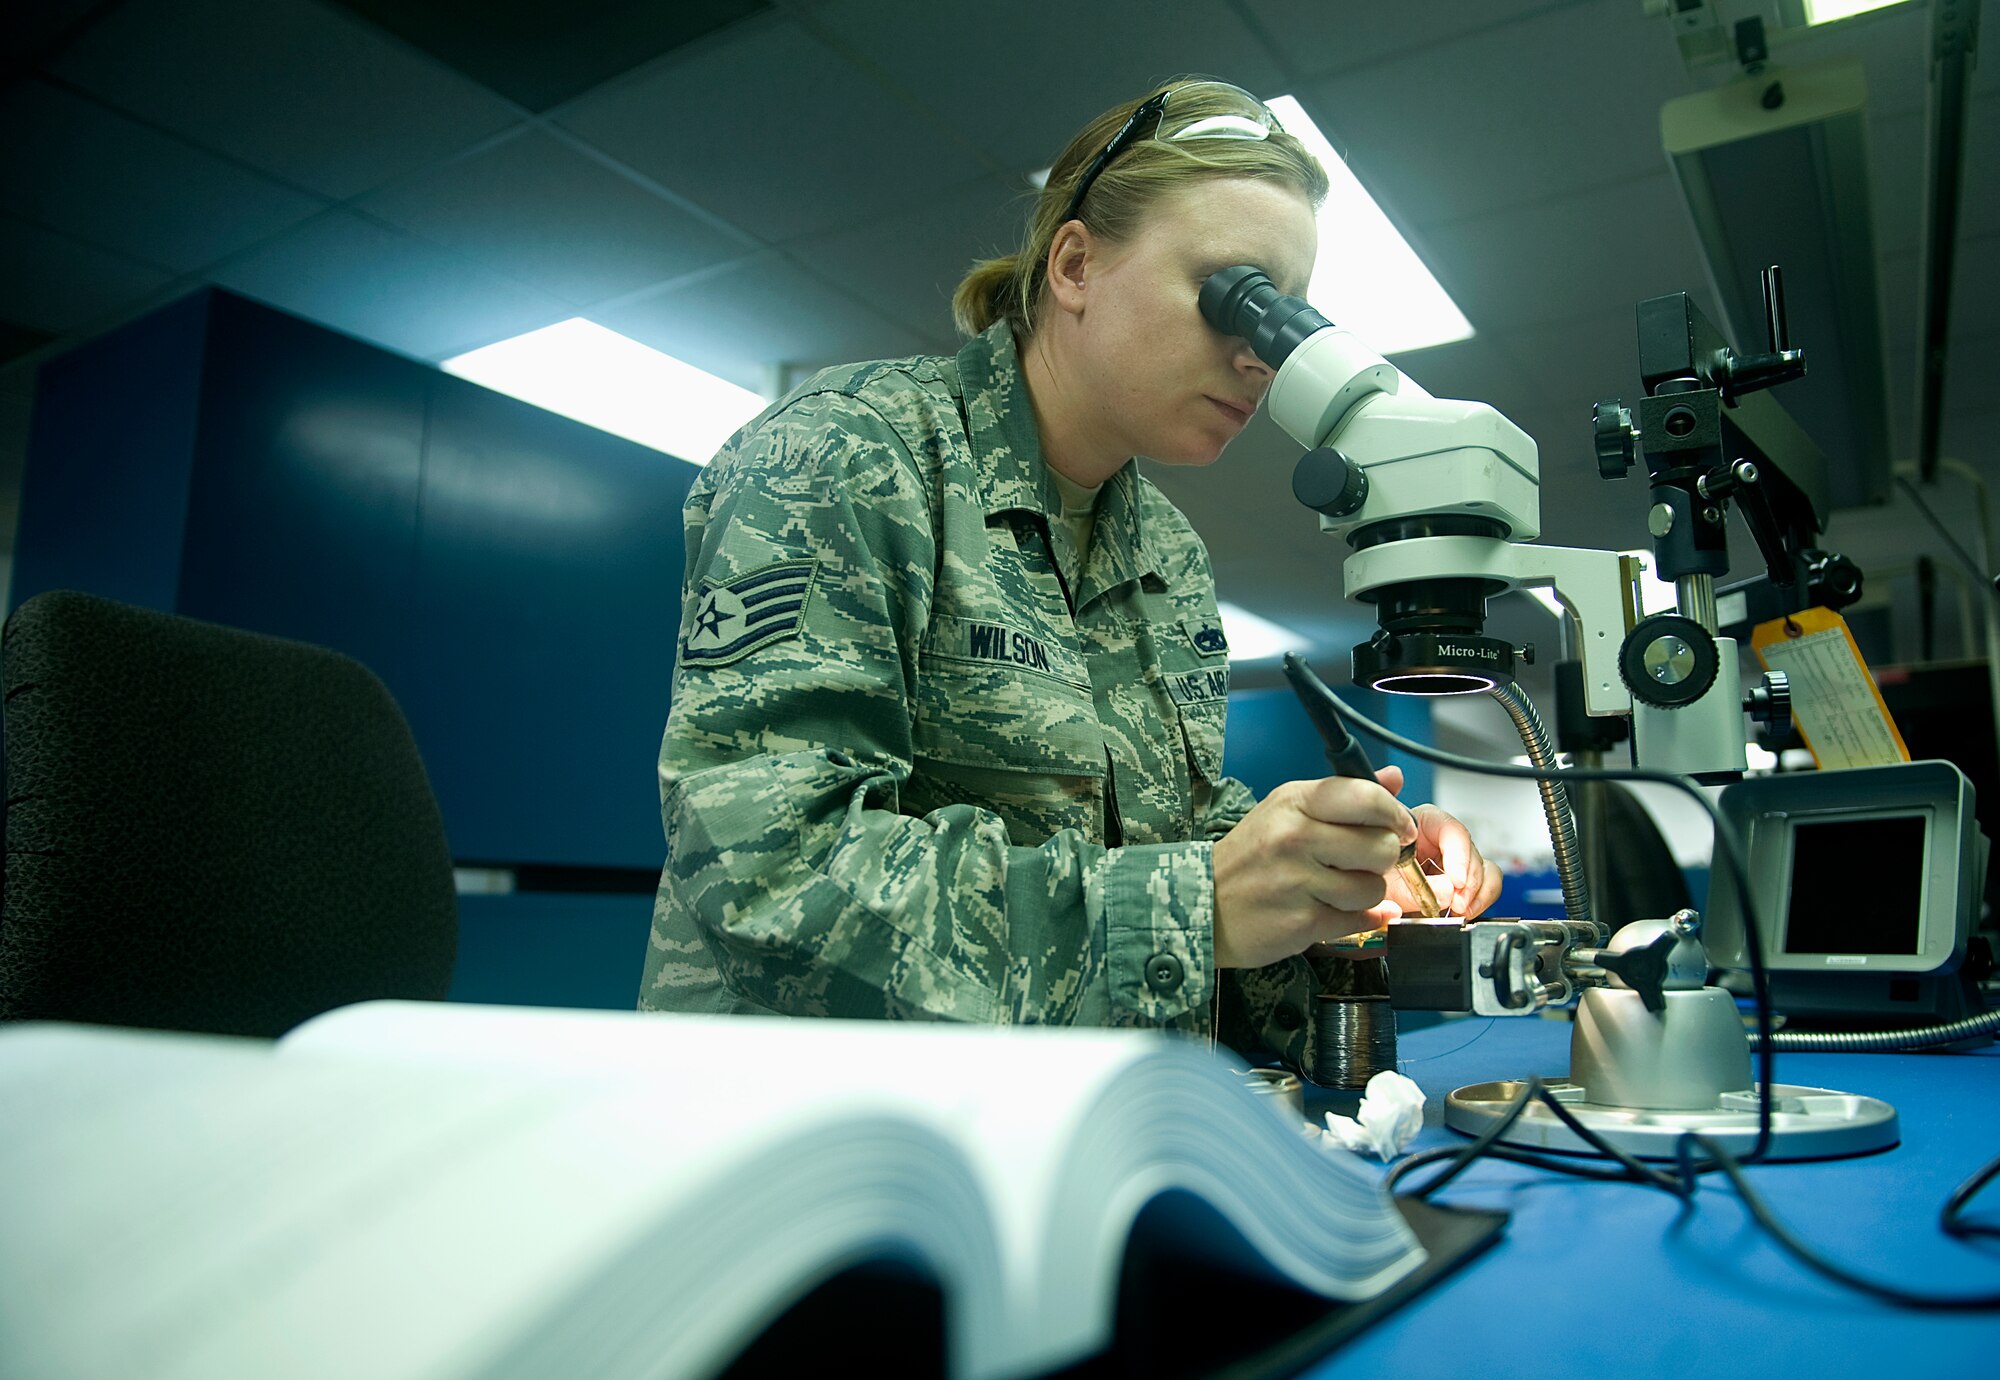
[284,1002,1422,1376]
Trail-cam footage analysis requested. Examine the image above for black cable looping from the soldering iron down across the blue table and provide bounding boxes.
[1328,676,2000,1312]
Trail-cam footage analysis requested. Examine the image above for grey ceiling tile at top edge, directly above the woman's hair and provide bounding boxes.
[812,0,1286,172]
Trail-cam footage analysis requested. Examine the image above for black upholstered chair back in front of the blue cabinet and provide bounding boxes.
[0,590,458,1036]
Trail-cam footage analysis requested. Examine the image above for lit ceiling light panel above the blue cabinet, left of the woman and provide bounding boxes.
[440,316,766,464]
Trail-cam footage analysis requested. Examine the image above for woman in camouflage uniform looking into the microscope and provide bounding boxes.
[640,82,1500,1068]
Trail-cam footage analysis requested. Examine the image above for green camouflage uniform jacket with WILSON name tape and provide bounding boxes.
[640,322,1314,1066]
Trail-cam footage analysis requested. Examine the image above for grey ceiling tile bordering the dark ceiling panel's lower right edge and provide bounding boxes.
[558,22,982,242]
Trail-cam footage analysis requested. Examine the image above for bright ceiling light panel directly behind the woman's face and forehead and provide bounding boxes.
[1270,96,1472,354]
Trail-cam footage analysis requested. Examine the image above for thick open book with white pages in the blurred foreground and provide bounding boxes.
[0,1002,1498,1380]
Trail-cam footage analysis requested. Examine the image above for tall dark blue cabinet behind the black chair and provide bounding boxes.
[12,290,696,872]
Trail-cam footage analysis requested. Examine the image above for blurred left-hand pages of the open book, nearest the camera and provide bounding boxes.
[0,1026,998,1380]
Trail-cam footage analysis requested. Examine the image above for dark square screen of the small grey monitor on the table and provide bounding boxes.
[1784,814,1928,954]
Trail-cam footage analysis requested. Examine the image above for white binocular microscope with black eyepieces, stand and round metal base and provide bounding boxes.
[1200,266,1928,1158]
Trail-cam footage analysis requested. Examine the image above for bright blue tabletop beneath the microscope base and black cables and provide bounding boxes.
[1308,1018,2000,1380]
